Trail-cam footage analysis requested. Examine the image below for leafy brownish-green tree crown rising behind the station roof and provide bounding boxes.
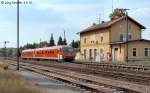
[109,8,128,20]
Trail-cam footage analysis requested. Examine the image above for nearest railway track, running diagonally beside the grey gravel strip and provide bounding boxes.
[3,59,126,93]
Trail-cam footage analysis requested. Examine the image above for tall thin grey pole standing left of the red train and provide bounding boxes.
[17,0,20,70]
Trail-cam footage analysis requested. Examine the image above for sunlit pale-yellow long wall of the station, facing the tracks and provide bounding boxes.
[80,29,110,61]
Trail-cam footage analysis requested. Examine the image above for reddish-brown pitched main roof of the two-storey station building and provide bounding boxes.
[79,16,146,33]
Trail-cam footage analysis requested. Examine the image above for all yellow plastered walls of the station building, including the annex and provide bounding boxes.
[80,19,147,62]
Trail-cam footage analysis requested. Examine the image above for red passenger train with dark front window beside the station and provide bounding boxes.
[21,46,75,61]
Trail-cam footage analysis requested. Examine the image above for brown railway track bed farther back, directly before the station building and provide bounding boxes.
[4,57,150,85]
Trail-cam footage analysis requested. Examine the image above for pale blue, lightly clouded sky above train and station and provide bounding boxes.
[0,0,150,47]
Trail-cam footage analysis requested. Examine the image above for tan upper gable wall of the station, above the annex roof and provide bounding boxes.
[111,19,141,42]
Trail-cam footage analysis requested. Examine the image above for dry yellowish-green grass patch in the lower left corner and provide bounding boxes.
[0,70,41,93]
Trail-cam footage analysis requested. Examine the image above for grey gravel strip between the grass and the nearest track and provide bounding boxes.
[9,66,91,93]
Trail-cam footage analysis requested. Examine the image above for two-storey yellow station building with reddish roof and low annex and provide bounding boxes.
[79,16,150,62]
